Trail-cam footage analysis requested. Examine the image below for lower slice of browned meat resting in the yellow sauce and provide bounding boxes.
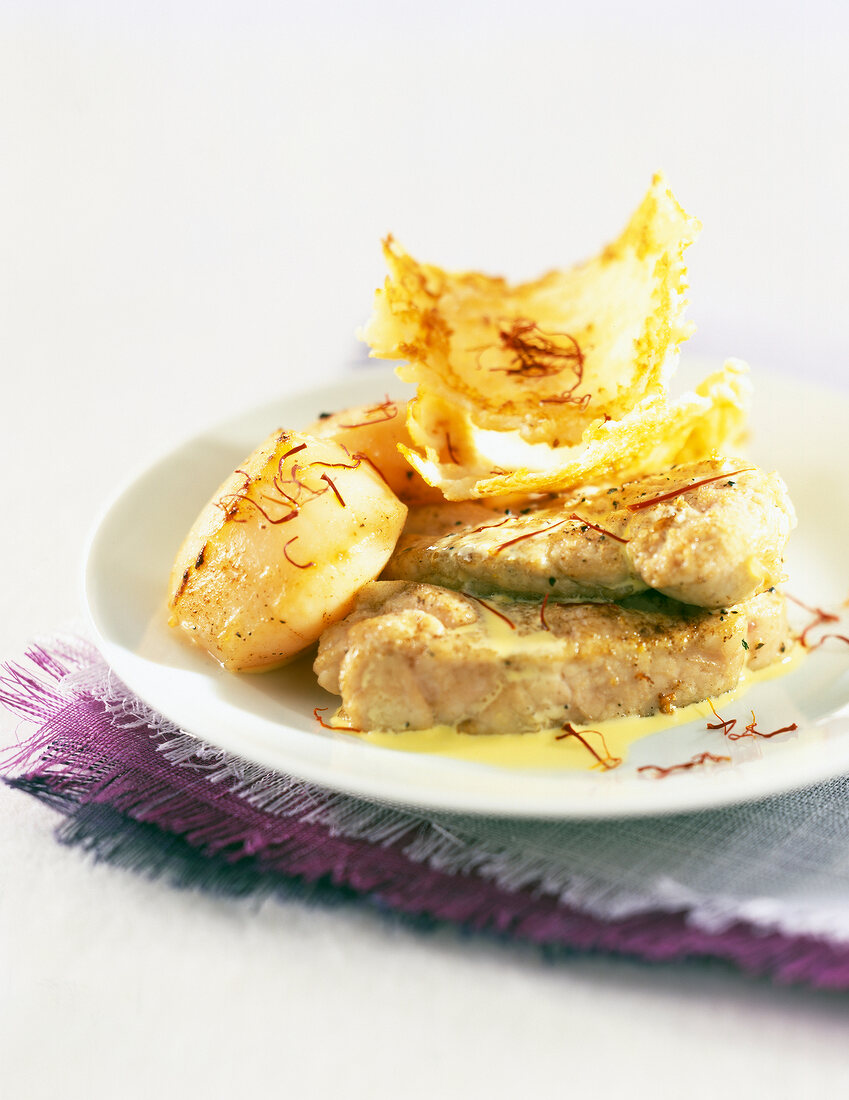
[316,581,787,734]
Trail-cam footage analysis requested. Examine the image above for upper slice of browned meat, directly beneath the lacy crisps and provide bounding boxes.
[383,459,796,607]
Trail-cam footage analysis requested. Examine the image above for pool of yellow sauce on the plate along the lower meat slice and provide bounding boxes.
[335,639,805,771]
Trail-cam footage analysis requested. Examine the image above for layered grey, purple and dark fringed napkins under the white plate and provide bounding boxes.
[0,639,849,989]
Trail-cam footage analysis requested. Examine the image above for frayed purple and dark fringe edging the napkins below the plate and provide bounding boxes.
[0,639,849,990]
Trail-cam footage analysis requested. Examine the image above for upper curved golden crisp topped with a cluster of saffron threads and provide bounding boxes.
[364,175,701,453]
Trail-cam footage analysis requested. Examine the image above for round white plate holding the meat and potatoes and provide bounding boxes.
[85,364,849,817]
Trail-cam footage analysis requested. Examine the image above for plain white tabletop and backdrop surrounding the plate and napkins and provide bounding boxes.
[0,0,849,1098]
